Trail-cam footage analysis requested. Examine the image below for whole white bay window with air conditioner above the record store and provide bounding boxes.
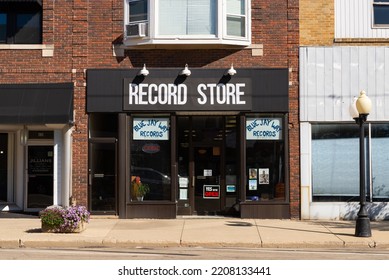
[124,0,251,45]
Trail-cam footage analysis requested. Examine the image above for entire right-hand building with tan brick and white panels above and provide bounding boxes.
[299,0,389,220]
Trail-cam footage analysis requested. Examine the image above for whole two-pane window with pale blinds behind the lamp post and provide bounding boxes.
[312,124,389,201]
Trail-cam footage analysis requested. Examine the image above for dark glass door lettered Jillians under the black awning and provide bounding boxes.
[27,145,54,208]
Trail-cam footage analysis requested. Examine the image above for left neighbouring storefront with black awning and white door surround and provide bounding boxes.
[0,83,73,212]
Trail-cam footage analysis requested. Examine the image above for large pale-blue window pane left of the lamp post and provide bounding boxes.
[312,124,360,201]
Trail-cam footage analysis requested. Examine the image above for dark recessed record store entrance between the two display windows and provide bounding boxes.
[177,116,240,215]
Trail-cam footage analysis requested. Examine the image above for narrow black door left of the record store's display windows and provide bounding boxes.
[89,139,117,214]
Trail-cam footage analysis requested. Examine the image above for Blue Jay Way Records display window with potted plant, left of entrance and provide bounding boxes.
[130,117,171,200]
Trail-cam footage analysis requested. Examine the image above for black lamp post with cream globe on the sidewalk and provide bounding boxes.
[350,91,371,237]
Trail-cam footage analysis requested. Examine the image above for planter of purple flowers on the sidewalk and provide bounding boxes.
[39,206,90,233]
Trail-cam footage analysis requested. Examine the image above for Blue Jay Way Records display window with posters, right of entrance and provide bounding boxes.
[246,115,285,201]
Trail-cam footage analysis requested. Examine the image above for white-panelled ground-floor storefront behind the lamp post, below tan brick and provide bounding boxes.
[300,46,389,220]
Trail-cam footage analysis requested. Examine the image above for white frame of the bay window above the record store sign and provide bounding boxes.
[123,0,251,48]
